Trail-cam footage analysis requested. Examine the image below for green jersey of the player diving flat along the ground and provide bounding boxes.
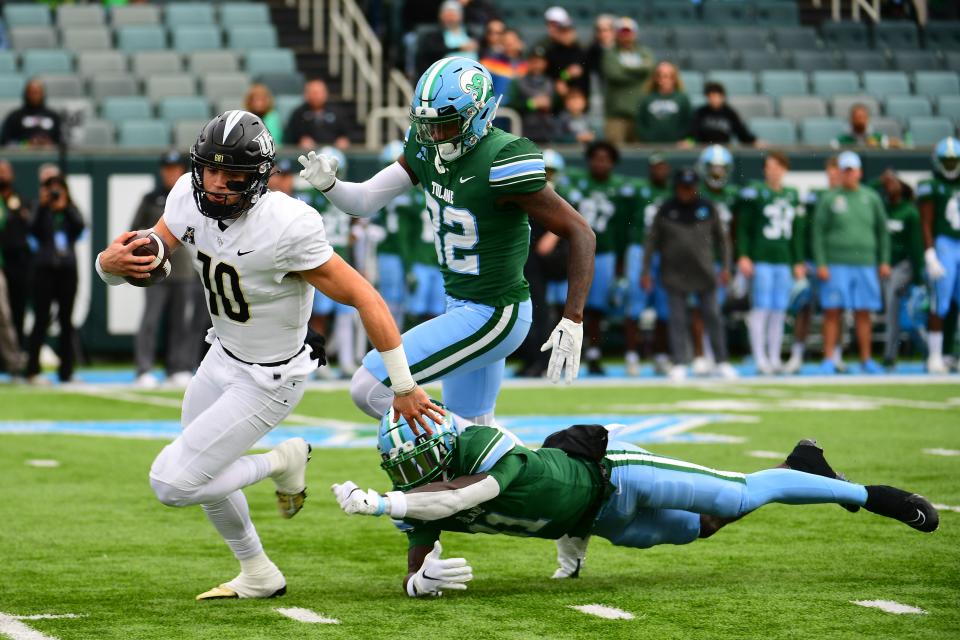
[404,426,604,547]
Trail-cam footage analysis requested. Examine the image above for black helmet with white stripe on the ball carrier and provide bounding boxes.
[190,110,276,220]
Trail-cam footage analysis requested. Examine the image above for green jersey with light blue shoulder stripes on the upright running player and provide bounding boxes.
[403,128,547,307]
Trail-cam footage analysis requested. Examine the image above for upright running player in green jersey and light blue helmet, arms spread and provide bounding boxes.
[300,57,594,424]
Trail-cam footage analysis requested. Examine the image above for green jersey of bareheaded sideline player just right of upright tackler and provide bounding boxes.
[568,174,638,254]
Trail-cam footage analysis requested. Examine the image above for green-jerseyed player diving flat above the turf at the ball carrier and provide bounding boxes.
[331,412,939,597]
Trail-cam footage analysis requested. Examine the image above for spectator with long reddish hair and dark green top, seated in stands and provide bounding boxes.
[637,62,691,142]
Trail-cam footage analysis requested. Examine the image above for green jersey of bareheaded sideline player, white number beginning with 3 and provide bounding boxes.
[734,182,800,264]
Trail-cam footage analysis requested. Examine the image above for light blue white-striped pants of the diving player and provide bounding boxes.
[593,442,867,549]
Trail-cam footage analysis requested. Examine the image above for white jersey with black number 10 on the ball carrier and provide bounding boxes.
[163,172,333,363]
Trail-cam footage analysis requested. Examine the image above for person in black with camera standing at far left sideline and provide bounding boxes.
[26,176,84,383]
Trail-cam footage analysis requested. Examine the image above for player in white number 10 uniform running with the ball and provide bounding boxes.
[96,111,442,600]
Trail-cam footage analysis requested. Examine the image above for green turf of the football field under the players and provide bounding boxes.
[0,385,960,640]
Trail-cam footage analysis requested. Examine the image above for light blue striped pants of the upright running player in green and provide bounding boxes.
[350,296,533,418]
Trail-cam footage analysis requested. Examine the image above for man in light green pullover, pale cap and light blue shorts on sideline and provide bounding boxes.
[813,151,890,374]
